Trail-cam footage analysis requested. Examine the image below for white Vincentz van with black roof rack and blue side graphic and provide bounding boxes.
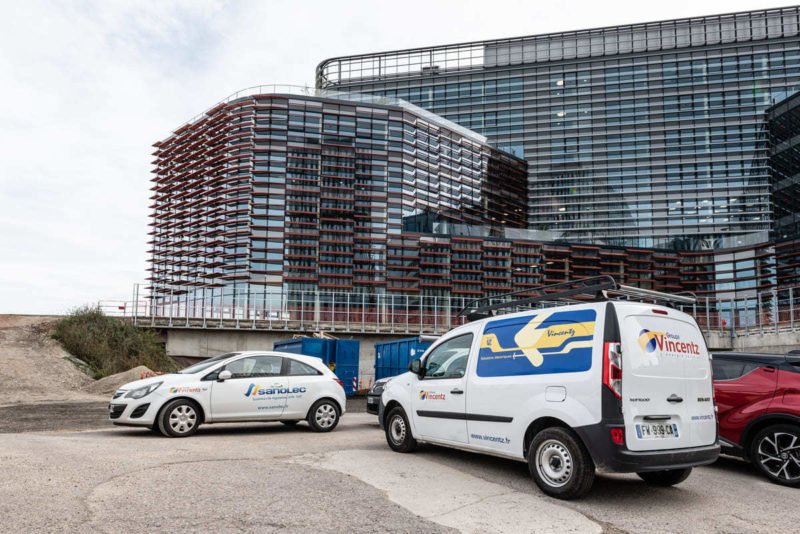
[379,276,720,499]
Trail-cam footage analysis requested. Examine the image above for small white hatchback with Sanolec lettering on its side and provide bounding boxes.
[108,351,345,437]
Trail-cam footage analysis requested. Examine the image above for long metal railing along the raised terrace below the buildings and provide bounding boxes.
[100,284,800,336]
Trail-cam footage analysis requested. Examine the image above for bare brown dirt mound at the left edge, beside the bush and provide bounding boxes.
[0,315,105,406]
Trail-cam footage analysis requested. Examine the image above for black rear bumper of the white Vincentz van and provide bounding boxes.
[575,425,720,473]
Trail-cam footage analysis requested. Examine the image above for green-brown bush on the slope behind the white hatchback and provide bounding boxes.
[53,306,180,378]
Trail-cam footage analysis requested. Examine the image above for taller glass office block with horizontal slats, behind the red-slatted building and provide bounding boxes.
[316,7,800,250]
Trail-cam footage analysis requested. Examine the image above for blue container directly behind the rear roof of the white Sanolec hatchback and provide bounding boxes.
[274,337,360,396]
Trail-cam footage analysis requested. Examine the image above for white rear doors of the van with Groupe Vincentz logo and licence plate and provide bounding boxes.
[614,303,717,451]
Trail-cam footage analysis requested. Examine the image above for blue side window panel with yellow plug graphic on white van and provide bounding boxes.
[477,309,597,377]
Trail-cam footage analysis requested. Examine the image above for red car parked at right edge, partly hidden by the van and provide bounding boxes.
[712,351,800,486]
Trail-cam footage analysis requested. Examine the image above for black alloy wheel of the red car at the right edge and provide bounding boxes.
[749,425,800,486]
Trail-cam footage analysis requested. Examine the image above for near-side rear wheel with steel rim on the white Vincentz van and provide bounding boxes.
[528,427,594,499]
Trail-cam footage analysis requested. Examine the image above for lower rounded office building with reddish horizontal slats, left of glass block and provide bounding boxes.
[150,86,526,300]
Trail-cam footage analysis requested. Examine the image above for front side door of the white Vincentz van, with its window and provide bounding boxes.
[411,333,474,443]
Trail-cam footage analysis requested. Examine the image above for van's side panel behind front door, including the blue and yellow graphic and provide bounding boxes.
[467,307,599,456]
